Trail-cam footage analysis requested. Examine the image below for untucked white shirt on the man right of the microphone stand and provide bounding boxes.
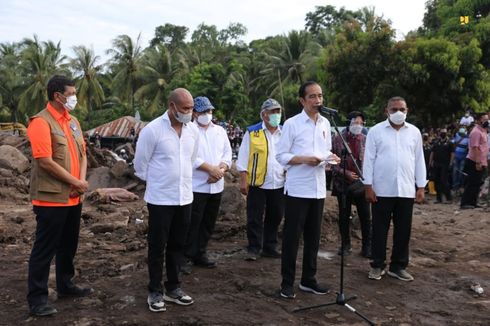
[363,120,427,198]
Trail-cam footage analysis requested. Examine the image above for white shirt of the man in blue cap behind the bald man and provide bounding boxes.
[192,122,231,194]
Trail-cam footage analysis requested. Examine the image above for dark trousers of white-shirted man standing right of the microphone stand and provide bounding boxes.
[371,197,414,271]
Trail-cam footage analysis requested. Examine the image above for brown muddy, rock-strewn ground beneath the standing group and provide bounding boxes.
[0,141,490,326]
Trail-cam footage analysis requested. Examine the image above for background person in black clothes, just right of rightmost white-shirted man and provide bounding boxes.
[429,128,454,203]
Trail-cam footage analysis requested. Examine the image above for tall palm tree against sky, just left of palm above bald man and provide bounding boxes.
[107,34,142,111]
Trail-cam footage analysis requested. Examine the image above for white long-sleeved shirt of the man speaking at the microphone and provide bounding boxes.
[276,110,332,199]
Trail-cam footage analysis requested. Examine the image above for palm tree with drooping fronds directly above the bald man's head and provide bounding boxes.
[135,44,178,115]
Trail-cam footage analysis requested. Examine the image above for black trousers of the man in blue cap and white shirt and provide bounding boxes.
[185,192,221,259]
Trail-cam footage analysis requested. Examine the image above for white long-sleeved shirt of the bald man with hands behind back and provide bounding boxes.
[134,111,199,206]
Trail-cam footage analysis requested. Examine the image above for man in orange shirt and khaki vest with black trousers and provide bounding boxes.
[27,76,93,316]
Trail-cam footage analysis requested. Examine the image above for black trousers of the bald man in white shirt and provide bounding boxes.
[148,204,191,293]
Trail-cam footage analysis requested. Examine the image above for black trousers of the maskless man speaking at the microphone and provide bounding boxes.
[281,195,325,286]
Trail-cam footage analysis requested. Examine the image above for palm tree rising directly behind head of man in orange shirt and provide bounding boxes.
[19,35,66,121]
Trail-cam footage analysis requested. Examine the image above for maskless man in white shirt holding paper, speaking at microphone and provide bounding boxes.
[276,81,340,299]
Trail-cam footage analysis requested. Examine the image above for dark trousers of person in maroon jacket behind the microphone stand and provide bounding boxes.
[337,194,371,251]
